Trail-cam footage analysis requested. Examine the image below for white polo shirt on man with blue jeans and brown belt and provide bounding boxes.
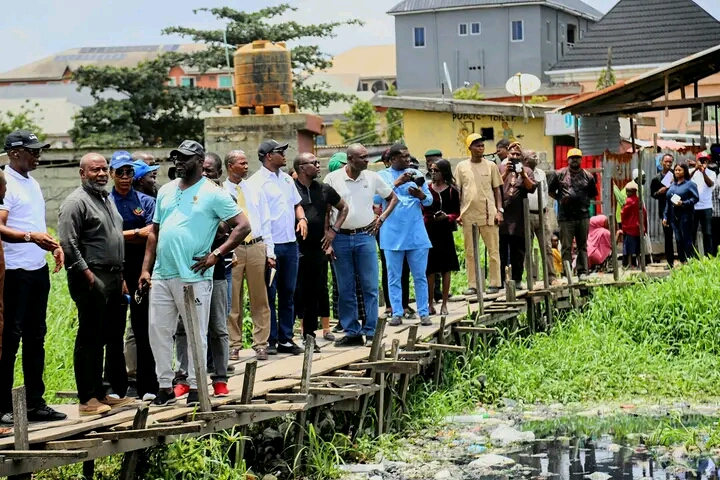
[325,167,392,229]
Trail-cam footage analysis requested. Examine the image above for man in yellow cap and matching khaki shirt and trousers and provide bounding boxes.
[455,133,503,295]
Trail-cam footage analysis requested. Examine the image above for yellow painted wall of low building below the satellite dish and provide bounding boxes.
[403,110,553,159]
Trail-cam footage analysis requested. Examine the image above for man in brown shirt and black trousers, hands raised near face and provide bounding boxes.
[500,142,537,289]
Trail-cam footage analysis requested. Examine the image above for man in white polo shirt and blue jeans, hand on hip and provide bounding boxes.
[325,144,400,347]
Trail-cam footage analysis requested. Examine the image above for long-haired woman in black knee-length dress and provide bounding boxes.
[423,159,460,315]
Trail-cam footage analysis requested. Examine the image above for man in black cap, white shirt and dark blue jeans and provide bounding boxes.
[248,140,307,355]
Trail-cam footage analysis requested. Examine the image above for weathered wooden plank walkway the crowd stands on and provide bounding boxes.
[0,272,667,476]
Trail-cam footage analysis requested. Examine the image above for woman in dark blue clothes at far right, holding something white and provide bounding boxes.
[663,163,700,263]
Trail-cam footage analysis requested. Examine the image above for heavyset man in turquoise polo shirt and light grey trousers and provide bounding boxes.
[138,140,250,405]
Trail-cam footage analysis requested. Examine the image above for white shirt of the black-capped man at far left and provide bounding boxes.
[0,165,47,271]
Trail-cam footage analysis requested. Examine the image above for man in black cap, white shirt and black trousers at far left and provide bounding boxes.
[0,130,66,424]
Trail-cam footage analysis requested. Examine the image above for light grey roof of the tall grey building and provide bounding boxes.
[388,0,602,20]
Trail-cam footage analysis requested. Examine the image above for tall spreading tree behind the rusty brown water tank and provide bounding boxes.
[163,3,362,112]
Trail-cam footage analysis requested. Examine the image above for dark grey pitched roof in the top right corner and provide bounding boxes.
[551,0,720,71]
